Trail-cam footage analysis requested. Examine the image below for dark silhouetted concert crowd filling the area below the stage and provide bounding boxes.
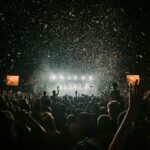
[0,82,150,150]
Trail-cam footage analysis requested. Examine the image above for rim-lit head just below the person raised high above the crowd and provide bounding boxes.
[107,100,120,118]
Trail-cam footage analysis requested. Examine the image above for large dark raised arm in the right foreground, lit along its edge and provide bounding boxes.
[108,83,143,150]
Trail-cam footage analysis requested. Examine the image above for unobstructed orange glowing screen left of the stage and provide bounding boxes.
[6,75,19,86]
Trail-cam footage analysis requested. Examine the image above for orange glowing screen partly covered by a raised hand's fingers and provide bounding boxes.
[127,75,140,85]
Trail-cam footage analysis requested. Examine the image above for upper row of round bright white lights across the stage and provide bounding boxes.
[50,74,93,81]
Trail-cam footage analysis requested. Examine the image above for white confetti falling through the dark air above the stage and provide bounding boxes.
[0,0,150,90]
